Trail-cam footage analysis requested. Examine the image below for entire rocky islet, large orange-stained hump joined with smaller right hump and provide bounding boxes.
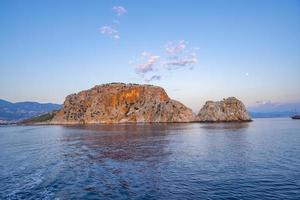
[44,83,251,124]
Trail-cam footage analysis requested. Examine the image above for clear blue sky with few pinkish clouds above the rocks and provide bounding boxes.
[0,0,300,111]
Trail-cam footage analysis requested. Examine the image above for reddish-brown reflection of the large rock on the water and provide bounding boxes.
[62,124,185,161]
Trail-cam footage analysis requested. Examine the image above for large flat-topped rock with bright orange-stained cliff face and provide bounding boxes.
[50,83,196,124]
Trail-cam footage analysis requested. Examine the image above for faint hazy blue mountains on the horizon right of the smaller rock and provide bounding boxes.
[247,102,300,118]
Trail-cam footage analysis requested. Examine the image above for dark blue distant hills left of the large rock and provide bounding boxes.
[0,99,61,123]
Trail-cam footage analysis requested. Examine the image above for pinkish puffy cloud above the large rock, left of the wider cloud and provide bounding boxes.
[136,52,160,74]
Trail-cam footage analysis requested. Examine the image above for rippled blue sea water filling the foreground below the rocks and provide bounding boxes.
[0,118,300,200]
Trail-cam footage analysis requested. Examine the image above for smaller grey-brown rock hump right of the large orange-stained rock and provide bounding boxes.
[198,97,251,122]
